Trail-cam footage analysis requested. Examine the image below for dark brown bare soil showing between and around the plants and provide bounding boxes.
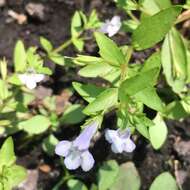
[0,0,190,190]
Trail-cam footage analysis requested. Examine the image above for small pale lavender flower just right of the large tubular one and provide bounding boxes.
[105,129,136,153]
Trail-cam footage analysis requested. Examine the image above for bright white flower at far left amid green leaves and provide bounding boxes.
[18,69,45,90]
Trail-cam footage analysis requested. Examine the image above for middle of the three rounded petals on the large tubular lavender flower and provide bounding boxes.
[64,152,81,170]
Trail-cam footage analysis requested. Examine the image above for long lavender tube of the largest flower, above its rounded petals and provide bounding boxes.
[73,121,98,150]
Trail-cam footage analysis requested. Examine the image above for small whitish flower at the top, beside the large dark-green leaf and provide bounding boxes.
[100,16,122,37]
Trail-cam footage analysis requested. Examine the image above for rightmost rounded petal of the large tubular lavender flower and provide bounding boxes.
[81,151,95,172]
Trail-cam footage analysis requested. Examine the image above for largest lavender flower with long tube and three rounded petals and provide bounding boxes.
[55,122,98,172]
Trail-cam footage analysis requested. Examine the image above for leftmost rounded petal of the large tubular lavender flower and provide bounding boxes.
[55,141,72,157]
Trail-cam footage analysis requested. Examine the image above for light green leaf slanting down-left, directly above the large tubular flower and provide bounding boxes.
[83,88,118,115]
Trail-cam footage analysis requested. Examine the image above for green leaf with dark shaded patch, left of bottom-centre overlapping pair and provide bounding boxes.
[98,160,119,190]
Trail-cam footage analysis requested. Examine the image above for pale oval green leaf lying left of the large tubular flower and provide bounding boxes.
[19,115,51,135]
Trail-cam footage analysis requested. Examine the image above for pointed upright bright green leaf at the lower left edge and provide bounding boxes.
[0,137,16,173]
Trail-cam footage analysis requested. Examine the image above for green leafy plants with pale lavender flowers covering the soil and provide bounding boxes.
[0,0,190,190]
